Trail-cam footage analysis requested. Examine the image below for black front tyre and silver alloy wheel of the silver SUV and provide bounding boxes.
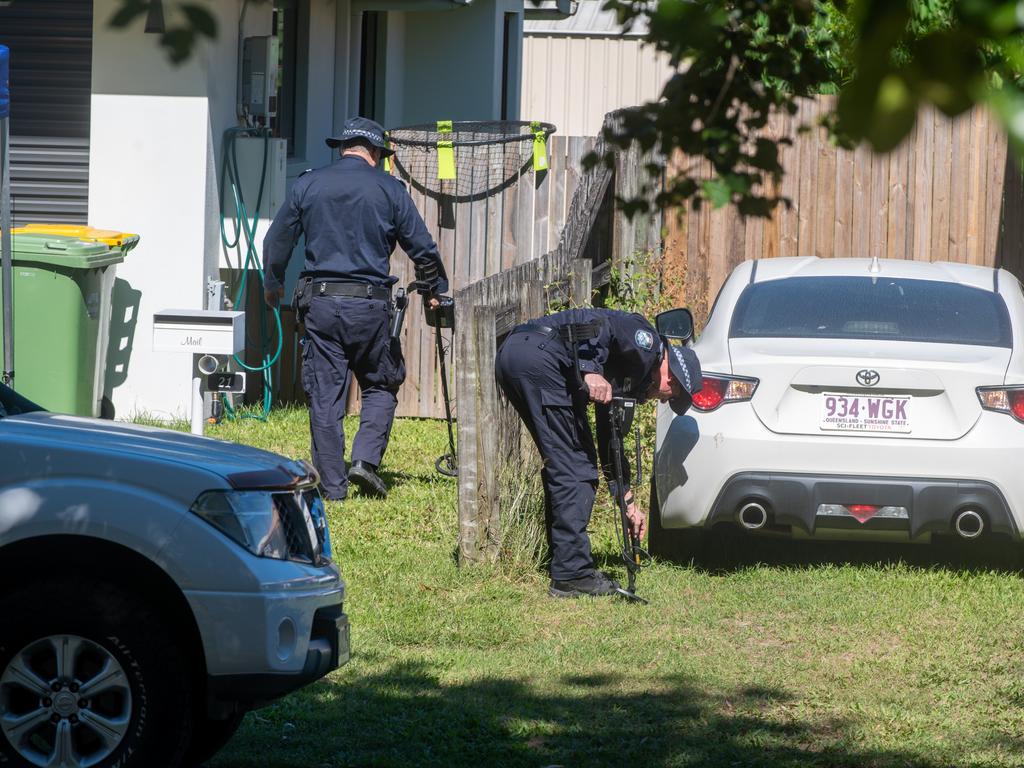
[0,580,191,768]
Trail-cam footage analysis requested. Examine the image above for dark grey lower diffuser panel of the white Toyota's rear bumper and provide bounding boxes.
[705,472,1019,539]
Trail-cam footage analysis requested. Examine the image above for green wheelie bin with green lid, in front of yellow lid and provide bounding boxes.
[0,230,124,417]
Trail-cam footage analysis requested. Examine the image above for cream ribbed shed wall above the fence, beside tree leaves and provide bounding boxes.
[522,34,672,136]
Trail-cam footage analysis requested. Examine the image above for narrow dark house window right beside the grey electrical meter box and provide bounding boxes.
[271,0,309,158]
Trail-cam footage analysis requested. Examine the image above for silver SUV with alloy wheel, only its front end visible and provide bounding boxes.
[0,385,349,768]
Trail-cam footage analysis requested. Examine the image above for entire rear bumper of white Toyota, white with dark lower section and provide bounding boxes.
[654,403,1024,539]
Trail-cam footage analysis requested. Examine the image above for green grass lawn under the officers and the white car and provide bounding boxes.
[203,410,1024,768]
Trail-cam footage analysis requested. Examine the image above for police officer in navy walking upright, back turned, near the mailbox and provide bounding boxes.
[263,118,447,499]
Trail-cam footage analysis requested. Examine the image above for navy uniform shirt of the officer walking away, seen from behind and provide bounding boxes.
[263,156,449,293]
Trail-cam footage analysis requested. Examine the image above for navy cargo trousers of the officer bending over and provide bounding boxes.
[495,331,597,581]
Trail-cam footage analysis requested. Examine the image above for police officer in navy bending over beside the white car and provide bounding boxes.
[495,309,701,597]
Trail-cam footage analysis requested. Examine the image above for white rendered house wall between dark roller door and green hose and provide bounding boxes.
[89,0,269,418]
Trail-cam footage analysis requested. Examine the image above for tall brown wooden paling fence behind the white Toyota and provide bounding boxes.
[665,96,1024,324]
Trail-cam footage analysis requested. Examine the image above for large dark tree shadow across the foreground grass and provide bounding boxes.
[216,664,940,768]
